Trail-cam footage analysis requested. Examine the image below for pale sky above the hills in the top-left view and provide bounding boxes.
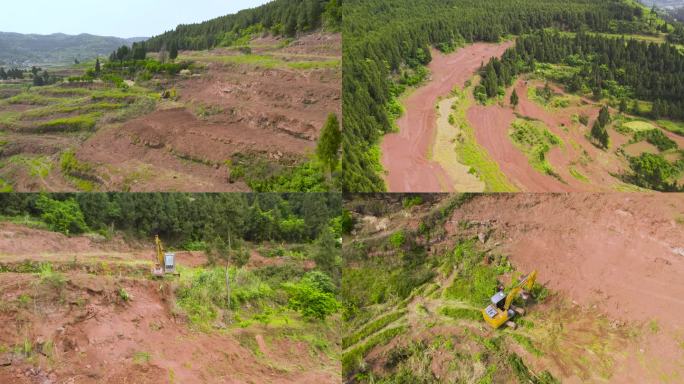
[0,0,269,38]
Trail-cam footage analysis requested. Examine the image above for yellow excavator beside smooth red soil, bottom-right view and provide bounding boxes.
[482,271,537,329]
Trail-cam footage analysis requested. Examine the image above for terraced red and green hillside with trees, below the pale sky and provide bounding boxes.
[0,0,342,192]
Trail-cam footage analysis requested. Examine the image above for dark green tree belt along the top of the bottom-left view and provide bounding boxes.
[0,193,342,244]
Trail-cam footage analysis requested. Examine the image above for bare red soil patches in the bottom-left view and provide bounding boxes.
[0,223,340,384]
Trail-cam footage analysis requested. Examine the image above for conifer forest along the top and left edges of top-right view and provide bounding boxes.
[343,0,668,192]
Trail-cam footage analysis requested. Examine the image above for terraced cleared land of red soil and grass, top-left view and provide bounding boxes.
[0,33,341,191]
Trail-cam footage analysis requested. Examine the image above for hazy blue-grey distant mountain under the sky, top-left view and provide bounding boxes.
[0,32,146,67]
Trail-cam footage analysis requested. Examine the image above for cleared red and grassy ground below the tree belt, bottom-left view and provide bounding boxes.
[0,222,340,384]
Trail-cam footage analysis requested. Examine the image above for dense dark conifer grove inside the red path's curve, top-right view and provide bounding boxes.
[476,30,684,119]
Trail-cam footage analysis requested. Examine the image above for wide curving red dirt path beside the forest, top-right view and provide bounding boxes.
[381,42,512,192]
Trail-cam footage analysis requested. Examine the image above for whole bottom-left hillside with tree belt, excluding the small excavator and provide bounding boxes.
[0,194,340,384]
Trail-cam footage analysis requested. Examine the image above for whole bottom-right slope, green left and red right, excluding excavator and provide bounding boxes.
[342,194,684,384]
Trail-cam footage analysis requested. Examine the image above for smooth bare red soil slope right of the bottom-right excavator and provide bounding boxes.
[447,193,684,383]
